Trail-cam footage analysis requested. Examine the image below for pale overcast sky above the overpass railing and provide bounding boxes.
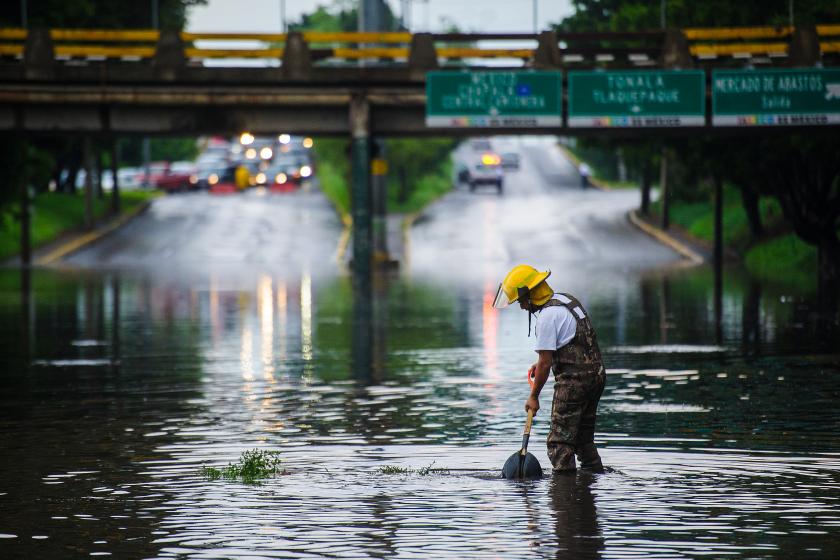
[187,0,573,33]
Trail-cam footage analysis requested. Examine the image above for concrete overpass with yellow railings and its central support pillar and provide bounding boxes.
[0,25,840,278]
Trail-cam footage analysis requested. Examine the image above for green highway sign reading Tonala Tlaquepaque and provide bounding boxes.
[568,70,706,128]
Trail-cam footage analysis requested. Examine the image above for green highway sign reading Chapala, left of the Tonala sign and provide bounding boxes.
[426,70,562,128]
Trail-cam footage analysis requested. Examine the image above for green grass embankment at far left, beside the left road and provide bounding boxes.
[0,191,158,259]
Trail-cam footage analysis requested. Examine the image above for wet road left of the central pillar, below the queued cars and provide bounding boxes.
[68,185,341,276]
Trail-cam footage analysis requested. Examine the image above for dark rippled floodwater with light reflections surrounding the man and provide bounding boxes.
[0,269,840,558]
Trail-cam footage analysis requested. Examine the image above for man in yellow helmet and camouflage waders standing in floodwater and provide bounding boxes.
[493,265,606,472]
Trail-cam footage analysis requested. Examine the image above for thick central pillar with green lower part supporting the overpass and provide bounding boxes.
[350,94,372,286]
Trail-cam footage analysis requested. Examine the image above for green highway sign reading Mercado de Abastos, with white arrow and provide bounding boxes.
[712,68,840,126]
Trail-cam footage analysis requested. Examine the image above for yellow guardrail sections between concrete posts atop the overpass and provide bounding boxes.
[0,24,840,66]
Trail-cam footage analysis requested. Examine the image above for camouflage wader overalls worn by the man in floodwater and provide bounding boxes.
[543,294,606,471]
